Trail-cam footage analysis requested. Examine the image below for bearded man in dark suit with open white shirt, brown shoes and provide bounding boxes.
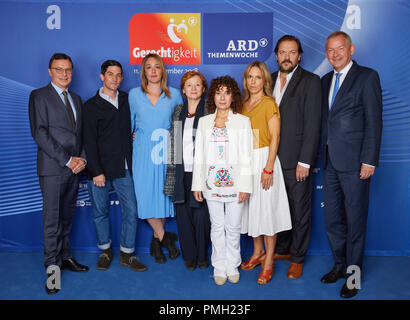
[272,35,321,279]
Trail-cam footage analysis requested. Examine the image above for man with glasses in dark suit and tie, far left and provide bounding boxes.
[29,53,88,294]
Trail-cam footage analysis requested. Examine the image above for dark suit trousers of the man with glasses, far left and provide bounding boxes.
[39,168,79,268]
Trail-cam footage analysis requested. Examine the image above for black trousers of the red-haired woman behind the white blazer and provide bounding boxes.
[175,172,211,261]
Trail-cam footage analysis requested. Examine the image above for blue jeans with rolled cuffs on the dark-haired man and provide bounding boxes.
[88,170,137,253]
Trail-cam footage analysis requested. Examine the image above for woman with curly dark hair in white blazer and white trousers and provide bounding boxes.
[192,76,253,285]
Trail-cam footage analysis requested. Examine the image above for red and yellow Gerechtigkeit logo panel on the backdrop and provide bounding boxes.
[129,13,201,65]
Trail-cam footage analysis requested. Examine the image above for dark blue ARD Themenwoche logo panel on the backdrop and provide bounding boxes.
[202,13,273,64]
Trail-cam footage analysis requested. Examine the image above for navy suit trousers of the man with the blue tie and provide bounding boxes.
[323,155,370,272]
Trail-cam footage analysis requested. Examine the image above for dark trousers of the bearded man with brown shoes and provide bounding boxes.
[275,169,313,263]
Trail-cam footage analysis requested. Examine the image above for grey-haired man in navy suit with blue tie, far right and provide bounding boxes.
[321,31,382,298]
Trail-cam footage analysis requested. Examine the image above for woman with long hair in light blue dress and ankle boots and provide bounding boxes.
[128,54,182,263]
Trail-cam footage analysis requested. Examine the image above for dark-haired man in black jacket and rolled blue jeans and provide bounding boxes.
[83,60,147,271]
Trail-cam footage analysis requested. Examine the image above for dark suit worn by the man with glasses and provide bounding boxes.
[29,83,85,268]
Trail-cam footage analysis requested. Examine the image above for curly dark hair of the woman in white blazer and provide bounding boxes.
[206,76,242,113]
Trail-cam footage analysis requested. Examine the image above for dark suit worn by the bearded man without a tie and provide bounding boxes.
[272,66,321,263]
